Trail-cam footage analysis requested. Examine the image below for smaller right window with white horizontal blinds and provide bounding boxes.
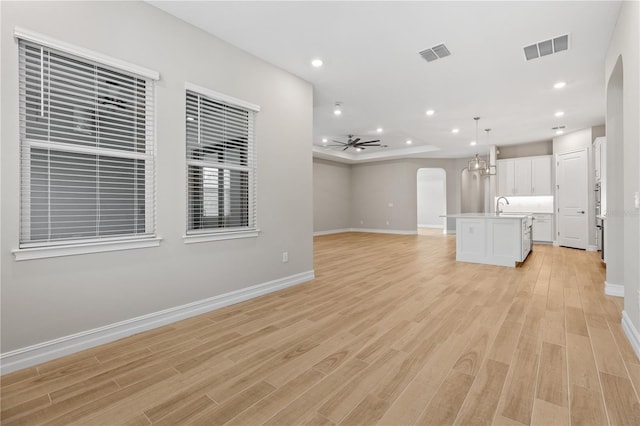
[186,86,257,234]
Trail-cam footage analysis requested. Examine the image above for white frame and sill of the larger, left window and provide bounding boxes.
[12,28,161,260]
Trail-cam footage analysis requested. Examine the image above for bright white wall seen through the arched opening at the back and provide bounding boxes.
[417,168,447,228]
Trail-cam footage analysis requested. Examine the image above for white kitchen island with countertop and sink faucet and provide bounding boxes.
[449,213,531,267]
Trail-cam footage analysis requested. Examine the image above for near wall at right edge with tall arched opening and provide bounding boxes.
[605,1,640,356]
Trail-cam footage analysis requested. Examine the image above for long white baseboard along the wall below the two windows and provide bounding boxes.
[0,270,315,374]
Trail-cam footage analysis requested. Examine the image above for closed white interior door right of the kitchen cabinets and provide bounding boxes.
[556,150,588,249]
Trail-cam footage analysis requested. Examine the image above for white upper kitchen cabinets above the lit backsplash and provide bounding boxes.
[497,155,553,195]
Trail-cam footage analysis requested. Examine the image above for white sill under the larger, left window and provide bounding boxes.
[12,237,162,261]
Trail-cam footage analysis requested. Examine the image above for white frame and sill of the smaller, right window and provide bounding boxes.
[183,82,260,244]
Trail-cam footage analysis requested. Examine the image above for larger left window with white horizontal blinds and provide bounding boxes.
[19,39,155,248]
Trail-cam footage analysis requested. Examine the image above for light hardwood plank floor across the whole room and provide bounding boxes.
[1,233,640,426]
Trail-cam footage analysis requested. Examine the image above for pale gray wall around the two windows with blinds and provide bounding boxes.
[0,2,313,358]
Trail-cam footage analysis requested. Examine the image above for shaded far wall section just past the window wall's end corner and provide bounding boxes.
[313,158,351,232]
